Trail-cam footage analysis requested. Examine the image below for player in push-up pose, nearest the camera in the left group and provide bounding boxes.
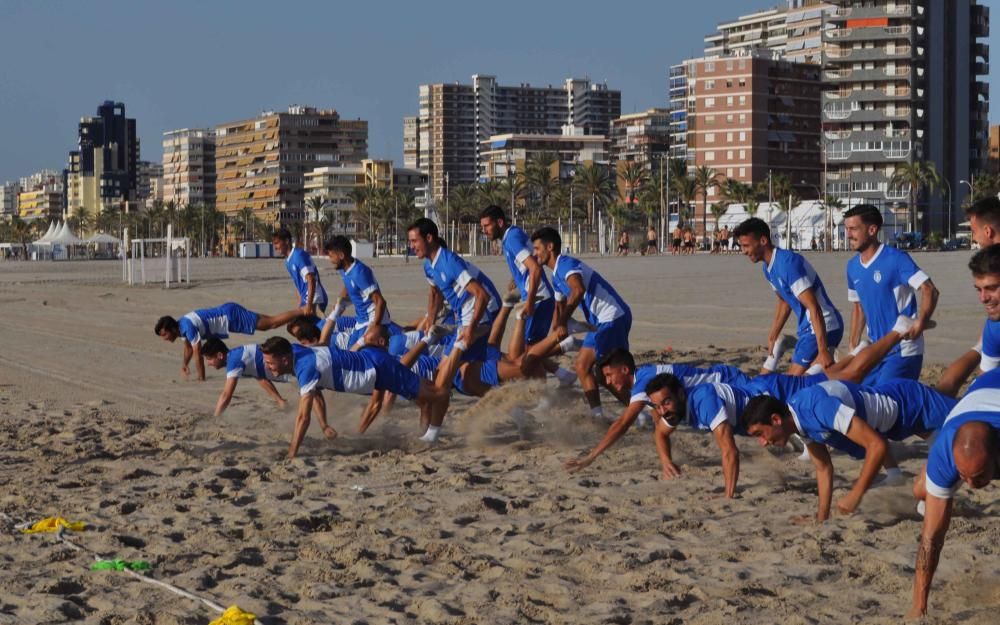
[261,336,448,458]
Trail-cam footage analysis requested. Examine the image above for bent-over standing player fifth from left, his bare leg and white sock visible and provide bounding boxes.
[531,228,632,418]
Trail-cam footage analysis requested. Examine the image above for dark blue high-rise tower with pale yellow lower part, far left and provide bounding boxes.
[66,100,139,217]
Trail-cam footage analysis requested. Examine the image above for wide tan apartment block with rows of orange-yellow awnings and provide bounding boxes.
[215,106,368,225]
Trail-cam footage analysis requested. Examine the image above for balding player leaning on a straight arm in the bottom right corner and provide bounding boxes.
[908,368,1000,618]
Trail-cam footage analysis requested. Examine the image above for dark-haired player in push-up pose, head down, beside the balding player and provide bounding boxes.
[741,380,956,521]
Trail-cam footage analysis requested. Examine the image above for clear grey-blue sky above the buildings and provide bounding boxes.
[0,0,1000,181]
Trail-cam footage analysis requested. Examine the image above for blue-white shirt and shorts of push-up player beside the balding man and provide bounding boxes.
[788,380,957,458]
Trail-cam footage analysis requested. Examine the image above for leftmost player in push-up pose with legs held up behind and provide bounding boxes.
[153,302,302,382]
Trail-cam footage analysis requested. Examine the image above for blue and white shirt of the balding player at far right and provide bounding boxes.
[927,369,1000,499]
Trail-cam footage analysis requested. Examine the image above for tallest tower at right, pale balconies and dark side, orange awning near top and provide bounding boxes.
[823,0,989,231]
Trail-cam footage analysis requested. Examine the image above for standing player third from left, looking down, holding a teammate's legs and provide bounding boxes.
[407,217,501,416]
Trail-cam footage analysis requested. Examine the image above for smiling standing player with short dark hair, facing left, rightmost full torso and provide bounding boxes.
[844,204,938,384]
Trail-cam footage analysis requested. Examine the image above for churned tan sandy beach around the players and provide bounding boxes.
[0,252,1000,625]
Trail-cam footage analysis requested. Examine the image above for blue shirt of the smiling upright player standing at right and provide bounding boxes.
[847,244,930,357]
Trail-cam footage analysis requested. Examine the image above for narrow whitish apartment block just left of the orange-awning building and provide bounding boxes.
[162,128,215,206]
